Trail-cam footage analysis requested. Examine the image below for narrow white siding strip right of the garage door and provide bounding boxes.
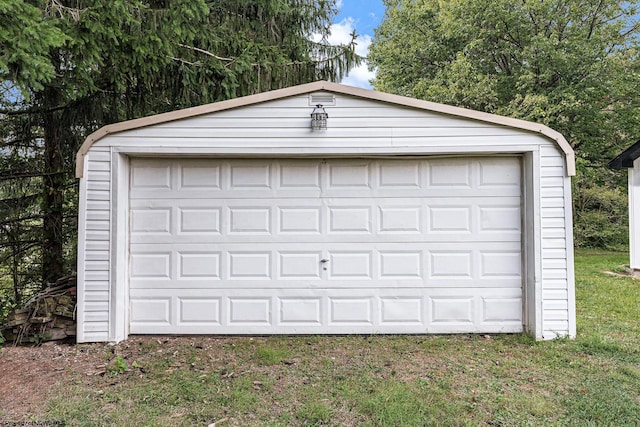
[540,144,571,339]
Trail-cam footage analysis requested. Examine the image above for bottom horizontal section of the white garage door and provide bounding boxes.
[131,288,522,334]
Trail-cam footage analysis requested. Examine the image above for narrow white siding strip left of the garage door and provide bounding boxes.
[78,147,111,342]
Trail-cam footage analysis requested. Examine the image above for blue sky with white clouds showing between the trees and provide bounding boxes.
[329,0,384,89]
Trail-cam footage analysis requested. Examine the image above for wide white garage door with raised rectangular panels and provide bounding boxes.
[129,157,522,334]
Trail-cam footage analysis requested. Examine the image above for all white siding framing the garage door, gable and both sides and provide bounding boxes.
[78,94,575,341]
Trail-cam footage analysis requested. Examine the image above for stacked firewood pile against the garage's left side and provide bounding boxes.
[1,276,76,344]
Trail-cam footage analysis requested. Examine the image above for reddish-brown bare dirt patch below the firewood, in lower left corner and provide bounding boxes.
[0,341,105,425]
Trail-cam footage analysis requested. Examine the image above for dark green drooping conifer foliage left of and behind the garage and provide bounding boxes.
[0,0,361,300]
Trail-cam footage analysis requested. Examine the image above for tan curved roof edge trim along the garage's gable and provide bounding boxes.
[76,81,576,178]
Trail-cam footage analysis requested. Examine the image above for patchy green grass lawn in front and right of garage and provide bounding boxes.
[7,252,640,426]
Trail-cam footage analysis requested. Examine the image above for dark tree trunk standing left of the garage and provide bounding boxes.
[42,95,64,285]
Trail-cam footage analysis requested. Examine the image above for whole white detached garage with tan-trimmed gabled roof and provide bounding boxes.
[76,82,576,342]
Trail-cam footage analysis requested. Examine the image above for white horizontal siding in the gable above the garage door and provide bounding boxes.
[94,96,541,153]
